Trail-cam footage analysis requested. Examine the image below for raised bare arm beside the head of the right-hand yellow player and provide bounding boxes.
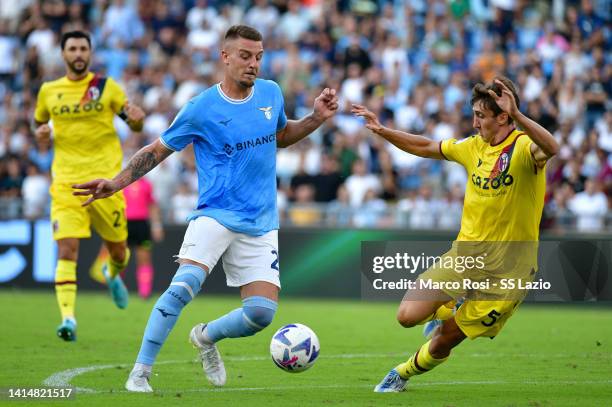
[489,79,559,167]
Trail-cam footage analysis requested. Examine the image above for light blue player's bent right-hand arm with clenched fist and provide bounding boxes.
[276,88,338,148]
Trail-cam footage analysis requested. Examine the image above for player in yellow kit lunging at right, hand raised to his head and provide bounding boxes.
[352,77,559,392]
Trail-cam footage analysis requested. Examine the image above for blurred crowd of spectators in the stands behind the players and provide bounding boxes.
[0,0,612,232]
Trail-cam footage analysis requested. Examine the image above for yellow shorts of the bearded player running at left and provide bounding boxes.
[50,183,127,242]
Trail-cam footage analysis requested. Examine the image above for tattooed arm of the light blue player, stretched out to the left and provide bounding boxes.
[72,139,173,206]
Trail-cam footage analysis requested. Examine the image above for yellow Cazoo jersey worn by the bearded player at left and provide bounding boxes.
[34,72,127,183]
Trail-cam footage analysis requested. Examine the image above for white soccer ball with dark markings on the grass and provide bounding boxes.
[270,324,321,373]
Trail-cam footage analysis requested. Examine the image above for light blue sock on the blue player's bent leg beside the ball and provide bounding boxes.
[206,296,278,342]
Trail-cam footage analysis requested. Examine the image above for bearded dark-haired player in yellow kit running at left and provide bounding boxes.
[34,31,144,341]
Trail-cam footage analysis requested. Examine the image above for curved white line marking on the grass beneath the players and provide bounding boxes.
[43,353,612,394]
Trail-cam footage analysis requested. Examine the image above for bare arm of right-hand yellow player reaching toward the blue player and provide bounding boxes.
[351,105,444,160]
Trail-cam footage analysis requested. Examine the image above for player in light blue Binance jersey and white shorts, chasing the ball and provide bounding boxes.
[74,25,338,392]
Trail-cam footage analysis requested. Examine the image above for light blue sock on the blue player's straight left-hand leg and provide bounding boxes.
[136,264,206,365]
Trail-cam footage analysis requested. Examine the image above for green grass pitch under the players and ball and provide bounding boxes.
[0,290,612,407]
